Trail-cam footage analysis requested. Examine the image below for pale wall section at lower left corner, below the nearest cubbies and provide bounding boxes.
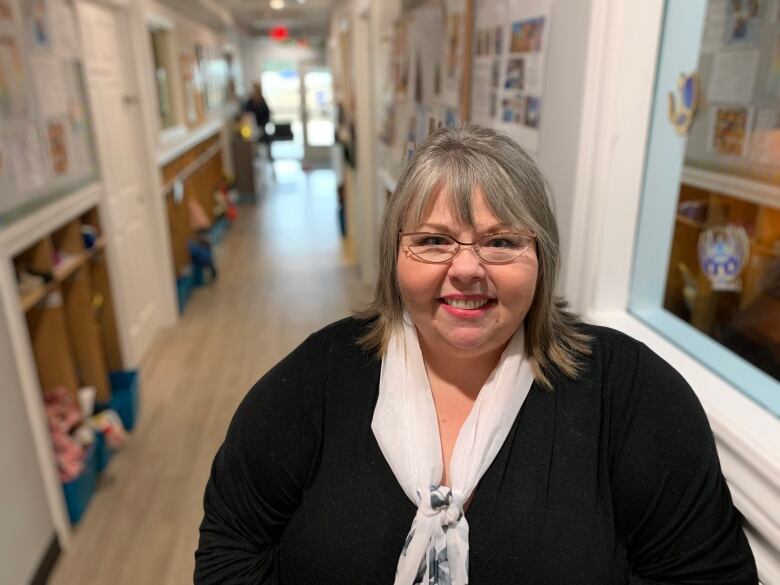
[0,298,54,583]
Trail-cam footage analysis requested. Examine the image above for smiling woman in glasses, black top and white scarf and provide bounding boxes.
[195,127,757,585]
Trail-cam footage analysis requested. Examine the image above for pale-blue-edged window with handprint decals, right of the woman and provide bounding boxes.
[630,0,780,415]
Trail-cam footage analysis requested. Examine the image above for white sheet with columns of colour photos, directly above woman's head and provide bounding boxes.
[497,0,550,152]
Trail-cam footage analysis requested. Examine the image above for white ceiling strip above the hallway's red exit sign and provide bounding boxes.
[160,0,339,37]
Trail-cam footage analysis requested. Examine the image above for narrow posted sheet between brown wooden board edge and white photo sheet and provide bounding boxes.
[471,2,509,127]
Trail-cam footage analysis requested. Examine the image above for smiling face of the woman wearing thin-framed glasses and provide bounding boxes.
[397,188,538,358]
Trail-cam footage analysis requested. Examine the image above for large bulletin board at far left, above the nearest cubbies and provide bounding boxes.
[0,0,97,225]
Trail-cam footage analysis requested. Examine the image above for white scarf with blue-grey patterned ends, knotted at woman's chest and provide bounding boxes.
[371,315,533,585]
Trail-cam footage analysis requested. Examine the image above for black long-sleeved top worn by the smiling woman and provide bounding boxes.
[195,319,757,585]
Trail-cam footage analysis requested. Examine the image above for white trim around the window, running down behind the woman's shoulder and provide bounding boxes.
[562,0,780,585]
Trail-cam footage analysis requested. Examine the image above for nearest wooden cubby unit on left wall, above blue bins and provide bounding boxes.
[14,208,123,402]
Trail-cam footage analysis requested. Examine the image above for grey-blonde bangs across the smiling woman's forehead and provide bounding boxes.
[398,152,536,232]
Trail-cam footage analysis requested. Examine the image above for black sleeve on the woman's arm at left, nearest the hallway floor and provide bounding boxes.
[194,342,322,585]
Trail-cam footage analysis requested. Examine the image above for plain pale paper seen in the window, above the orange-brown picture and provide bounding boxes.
[707,51,761,104]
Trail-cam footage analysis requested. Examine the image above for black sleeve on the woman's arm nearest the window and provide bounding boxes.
[610,344,758,585]
